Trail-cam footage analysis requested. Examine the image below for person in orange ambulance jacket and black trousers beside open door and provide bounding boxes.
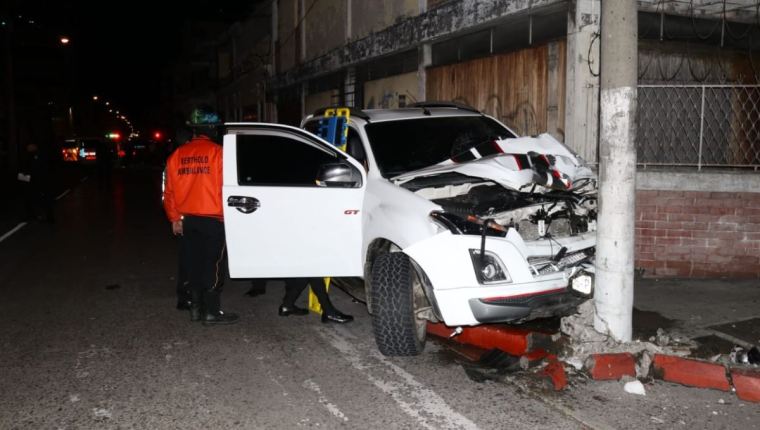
[164,109,239,325]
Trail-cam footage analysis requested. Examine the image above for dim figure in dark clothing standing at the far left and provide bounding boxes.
[18,143,53,222]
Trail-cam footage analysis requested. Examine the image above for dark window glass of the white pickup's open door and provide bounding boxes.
[237,134,341,187]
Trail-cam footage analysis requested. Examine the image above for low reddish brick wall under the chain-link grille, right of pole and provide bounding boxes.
[636,191,760,278]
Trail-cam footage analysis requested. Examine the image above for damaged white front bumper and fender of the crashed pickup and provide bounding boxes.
[403,228,596,326]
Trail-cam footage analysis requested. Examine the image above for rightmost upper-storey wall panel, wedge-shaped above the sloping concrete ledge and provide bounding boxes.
[348,0,419,40]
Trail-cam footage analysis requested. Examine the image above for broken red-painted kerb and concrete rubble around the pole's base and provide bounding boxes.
[428,303,760,402]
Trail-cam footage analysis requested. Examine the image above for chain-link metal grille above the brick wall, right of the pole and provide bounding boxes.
[636,85,760,170]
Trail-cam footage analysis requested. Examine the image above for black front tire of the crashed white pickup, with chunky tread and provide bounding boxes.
[372,252,427,356]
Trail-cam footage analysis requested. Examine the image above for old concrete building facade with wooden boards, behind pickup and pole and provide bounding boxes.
[212,0,760,278]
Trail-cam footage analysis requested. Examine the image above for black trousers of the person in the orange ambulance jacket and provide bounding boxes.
[182,216,227,313]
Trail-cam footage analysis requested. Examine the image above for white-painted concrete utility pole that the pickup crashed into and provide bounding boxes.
[594,0,638,342]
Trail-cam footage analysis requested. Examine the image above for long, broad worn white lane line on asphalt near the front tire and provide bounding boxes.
[317,329,478,430]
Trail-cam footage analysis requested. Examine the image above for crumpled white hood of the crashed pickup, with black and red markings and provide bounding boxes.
[391,133,594,190]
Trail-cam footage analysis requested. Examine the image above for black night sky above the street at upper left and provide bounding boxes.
[11,0,256,127]
